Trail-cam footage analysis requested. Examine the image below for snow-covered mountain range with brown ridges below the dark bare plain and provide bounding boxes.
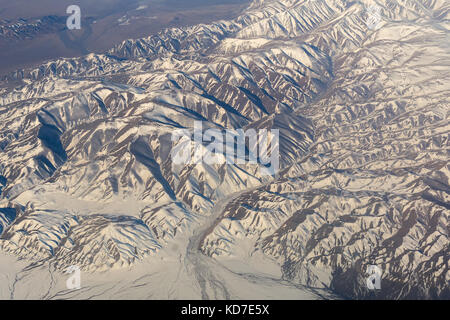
[0,0,450,299]
